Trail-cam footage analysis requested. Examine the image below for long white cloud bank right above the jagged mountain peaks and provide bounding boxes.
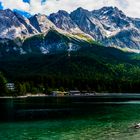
[0,0,140,17]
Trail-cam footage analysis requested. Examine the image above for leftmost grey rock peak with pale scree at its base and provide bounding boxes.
[0,9,36,39]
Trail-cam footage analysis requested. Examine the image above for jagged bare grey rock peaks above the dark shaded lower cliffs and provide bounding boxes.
[0,7,140,53]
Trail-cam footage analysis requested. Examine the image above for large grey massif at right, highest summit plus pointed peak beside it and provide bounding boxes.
[71,7,140,49]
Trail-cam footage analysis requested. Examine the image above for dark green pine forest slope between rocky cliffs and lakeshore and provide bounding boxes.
[0,45,140,95]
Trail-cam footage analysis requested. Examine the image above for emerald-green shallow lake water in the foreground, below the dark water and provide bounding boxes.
[0,101,140,140]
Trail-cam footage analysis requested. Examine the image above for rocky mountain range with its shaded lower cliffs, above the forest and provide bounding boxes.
[0,7,140,56]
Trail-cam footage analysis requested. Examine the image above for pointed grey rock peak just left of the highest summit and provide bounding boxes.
[70,8,104,40]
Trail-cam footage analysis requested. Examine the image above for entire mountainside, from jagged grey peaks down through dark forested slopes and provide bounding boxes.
[0,7,140,93]
